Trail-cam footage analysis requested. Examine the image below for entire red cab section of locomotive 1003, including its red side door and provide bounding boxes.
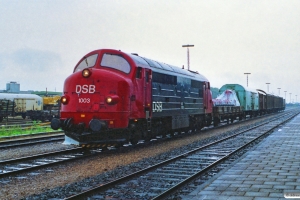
[51,50,151,145]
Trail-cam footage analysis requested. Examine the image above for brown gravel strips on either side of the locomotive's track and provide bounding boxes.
[0,115,276,199]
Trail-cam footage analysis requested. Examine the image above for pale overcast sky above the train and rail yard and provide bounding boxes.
[0,0,300,102]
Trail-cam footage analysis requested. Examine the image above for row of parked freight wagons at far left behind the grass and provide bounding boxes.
[0,93,60,122]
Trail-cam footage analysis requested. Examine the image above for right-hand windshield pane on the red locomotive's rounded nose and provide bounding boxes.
[100,53,131,74]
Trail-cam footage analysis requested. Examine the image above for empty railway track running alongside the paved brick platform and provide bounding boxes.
[62,109,299,199]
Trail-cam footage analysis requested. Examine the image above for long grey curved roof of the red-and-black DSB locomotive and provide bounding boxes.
[128,54,208,81]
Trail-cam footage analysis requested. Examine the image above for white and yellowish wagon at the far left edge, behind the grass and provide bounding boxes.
[0,93,43,119]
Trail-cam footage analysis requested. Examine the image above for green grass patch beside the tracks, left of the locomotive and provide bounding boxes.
[0,121,54,137]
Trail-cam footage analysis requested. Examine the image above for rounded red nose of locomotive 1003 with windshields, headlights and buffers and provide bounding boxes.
[51,51,131,147]
